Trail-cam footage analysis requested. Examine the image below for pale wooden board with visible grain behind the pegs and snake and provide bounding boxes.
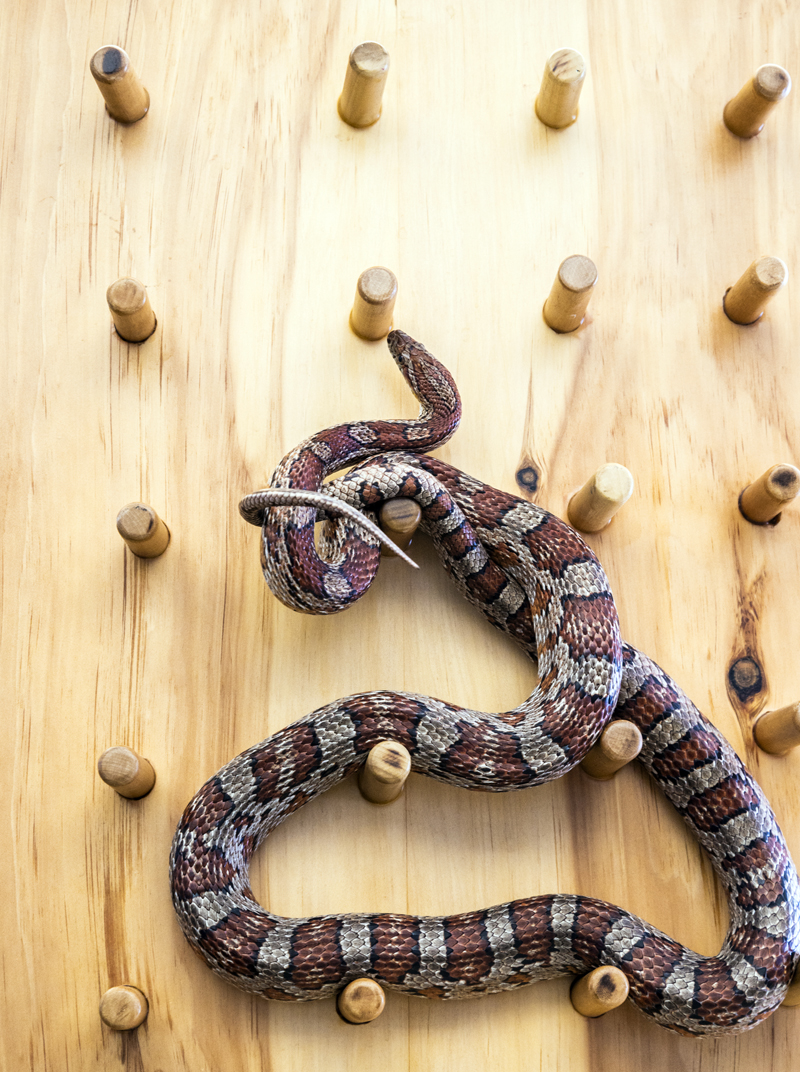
[0,0,800,1072]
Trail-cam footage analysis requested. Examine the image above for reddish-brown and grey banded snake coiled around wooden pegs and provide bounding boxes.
[171,331,800,1036]
